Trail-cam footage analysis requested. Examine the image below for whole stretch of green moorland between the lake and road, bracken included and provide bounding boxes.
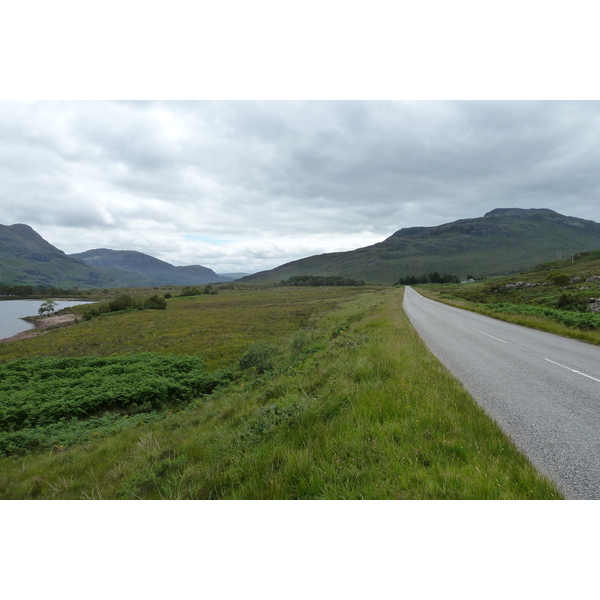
[0,284,562,499]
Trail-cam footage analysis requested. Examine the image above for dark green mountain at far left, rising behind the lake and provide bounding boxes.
[0,223,110,288]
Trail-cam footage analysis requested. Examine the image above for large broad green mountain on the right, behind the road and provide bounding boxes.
[240,208,600,283]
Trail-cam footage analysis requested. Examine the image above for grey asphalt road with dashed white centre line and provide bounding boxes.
[403,287,600,499]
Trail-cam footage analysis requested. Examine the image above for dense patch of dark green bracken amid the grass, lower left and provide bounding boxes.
[0,354,232,456]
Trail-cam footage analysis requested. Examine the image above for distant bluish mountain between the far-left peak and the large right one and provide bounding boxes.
[69,248,231,286]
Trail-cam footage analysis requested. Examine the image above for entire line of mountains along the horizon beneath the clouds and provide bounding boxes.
[0,208,600,289]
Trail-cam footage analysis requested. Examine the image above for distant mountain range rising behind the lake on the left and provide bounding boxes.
[0,224,234,289]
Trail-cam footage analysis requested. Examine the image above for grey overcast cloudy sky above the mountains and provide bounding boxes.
[0,101,600,272]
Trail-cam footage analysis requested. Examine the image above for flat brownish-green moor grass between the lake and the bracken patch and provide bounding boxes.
[0,286,375,368]
